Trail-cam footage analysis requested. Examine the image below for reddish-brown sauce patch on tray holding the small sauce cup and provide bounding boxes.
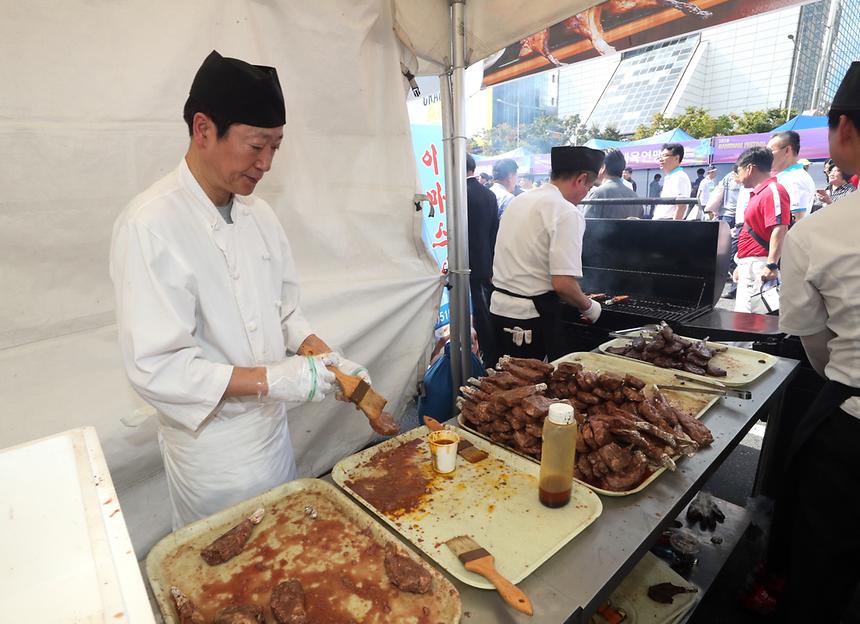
[345,438,434,515]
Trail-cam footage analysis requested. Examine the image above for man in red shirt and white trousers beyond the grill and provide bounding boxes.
[733,147,791,314]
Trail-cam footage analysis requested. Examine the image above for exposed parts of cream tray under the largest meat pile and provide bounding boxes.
[457,351,719,496]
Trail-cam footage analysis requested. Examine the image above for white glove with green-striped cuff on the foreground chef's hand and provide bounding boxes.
[266,353,340,403]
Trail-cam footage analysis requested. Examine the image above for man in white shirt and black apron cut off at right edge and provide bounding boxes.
[768,61,860,622]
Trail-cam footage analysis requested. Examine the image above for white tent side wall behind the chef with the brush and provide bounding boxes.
[0,0,442,554]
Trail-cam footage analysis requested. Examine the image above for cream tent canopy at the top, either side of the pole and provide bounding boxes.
[394,0,599,74]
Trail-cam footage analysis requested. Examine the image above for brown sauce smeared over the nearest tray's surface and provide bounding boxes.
[164,492,450,624]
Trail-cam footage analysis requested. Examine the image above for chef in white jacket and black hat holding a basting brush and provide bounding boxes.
[110,51,369,528]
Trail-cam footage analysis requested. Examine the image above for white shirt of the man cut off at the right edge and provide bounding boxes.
[779,193,860,418]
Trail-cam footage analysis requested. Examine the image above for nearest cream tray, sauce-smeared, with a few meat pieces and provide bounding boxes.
[146,479,462,624]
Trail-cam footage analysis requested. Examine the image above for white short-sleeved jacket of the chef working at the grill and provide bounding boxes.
[490,182,585,319]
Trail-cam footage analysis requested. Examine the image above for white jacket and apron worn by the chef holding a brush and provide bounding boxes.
[110,159,312,527]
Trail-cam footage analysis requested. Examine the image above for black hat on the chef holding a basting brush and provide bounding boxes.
[188,50,286,128]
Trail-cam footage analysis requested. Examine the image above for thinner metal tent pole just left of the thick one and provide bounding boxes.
[439,67,465,404]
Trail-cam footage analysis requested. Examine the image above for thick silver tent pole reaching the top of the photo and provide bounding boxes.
[448,0,472,394]
